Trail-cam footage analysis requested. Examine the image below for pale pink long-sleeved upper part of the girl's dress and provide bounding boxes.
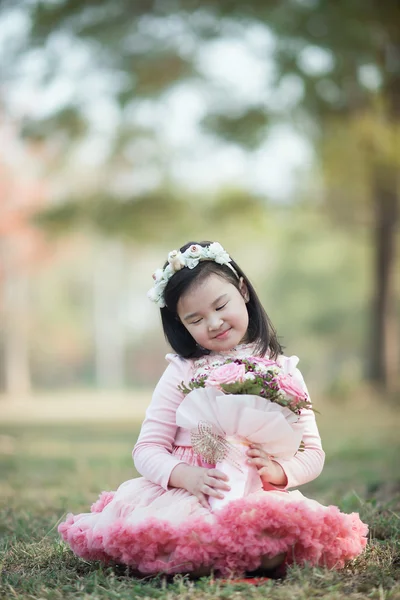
[133,354,325,490]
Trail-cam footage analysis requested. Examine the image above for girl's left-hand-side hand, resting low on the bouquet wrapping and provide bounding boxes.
[169,464,231,509]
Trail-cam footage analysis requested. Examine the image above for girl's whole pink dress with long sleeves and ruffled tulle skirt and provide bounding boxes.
[58,345,367,576]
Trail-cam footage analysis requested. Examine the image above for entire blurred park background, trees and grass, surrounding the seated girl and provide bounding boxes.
[0,7,400,600]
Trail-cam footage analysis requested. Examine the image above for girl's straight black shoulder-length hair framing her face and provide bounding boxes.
[160,241,283,359]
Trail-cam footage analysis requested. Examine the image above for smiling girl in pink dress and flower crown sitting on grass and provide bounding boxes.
[59,242,367,576]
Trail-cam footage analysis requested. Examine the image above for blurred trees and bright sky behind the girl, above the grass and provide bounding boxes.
[0,0,400,417]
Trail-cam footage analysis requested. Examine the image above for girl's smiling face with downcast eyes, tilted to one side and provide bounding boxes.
[177,273,249,352]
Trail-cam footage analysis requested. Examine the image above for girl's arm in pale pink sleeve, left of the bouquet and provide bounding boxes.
[132,354,192,489]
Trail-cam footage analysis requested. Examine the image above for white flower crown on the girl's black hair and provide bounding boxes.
[147,242,239,308]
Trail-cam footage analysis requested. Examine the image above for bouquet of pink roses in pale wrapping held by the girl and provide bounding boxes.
[176,356,311,506]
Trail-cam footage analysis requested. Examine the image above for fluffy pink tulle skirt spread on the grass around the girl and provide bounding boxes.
[58,446,368,576]
